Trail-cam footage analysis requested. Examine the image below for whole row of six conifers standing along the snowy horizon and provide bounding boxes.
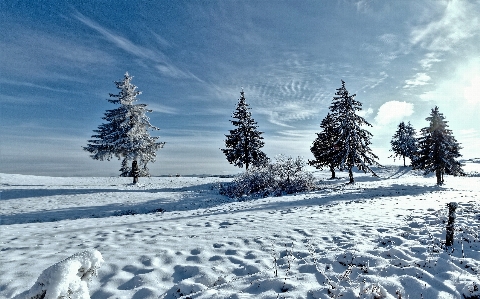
[83,72,463,185]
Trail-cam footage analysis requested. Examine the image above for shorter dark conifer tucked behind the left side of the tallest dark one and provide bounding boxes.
[308,113,342,179]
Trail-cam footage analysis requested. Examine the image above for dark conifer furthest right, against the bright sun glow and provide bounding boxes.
[412,106,464,185]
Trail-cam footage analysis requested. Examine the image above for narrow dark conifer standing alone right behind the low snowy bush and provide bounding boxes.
[222,90,268,170]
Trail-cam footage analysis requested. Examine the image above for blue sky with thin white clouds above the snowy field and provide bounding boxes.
[0,0,480,176]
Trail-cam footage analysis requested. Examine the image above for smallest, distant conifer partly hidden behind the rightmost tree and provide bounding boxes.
[389,121,418,166]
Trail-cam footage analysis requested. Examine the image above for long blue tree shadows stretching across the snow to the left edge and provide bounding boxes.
[0,178,442,225]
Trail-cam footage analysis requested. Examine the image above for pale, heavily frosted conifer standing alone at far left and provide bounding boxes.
[83,72,165,177]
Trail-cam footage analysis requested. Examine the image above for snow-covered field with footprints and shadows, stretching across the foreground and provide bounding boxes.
[0,163,480,299]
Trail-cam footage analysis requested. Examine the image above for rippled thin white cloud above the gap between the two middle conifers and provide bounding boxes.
[207,53,341,128]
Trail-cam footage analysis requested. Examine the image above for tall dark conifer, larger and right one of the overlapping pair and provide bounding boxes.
[330,80,380,183]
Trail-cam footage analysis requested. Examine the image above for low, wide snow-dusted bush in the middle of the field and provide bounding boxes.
[220,155,315,198]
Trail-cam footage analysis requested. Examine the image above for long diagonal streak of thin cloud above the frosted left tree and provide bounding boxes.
[74,12,203,82]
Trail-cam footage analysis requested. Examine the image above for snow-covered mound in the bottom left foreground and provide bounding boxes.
[20,249,103,299]
